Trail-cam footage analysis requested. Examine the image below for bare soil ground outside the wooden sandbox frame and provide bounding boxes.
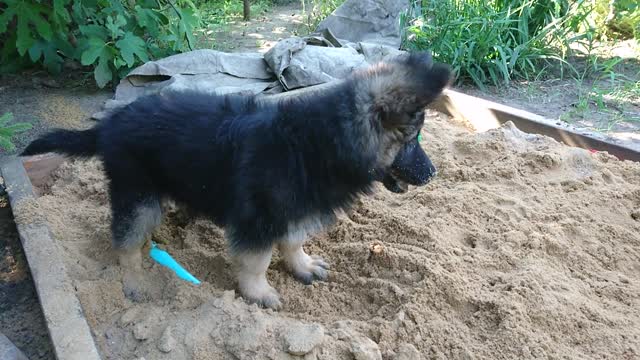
[0,2,640,359]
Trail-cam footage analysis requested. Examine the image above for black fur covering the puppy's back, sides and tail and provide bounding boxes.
[23,52,449,255]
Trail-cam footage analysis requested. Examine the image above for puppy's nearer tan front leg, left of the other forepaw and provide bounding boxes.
[232,248,282,310]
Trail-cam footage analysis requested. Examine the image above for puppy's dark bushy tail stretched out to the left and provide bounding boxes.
[20,129,98,157]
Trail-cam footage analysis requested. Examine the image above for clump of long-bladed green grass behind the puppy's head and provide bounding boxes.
[400,0,589,87]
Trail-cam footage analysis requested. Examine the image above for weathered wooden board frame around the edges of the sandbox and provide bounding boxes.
[0,88,640,360]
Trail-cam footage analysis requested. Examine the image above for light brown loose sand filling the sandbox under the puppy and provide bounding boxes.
[16,113,640,360]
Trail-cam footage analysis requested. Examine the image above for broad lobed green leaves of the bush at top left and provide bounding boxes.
[0,0,199,87]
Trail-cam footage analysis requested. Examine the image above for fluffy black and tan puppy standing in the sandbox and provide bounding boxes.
[23,53,450,308]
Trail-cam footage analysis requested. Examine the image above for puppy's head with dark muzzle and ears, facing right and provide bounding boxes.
[360,52,451,192]
